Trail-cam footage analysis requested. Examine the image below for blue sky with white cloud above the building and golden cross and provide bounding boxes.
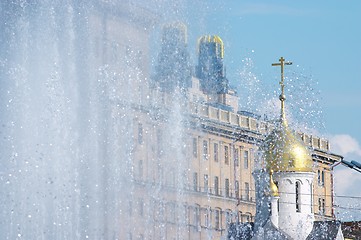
[179,0,361,220]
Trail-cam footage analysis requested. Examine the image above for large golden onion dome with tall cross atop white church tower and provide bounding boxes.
[263,58,313,172]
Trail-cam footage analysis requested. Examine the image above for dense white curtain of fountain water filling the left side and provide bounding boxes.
[0,1,191,239]
